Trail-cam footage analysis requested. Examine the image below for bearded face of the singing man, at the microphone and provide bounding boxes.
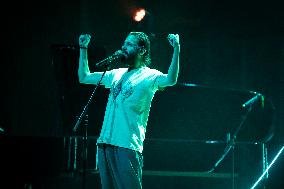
[122,35,140,60]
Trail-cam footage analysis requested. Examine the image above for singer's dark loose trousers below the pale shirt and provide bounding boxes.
[97,144,143,189]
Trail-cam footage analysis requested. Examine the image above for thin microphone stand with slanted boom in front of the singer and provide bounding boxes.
[73,67,108,189]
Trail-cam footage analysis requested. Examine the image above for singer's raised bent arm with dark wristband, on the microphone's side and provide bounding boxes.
[78,34,103,84]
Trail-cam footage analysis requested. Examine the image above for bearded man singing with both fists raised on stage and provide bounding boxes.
[78,32,180,189]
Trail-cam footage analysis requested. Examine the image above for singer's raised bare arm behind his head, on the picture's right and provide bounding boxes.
[155,34,180,88]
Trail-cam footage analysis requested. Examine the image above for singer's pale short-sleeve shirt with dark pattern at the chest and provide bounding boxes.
[97,67,163,153]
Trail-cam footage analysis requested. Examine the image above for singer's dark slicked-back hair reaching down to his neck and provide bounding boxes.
[128,32,151,66]
